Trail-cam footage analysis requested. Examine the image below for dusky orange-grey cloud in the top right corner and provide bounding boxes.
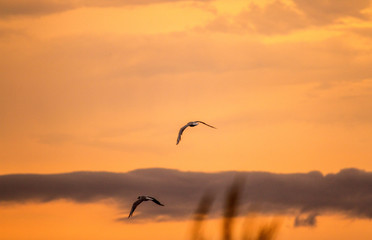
[204,0,371,35]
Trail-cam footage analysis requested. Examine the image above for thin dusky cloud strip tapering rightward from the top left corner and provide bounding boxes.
[0,0,212,17]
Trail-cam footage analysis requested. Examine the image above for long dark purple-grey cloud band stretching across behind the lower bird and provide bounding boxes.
[0,168,372,221]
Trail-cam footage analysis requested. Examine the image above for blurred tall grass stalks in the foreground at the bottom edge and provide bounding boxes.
[191,177,280,240]
